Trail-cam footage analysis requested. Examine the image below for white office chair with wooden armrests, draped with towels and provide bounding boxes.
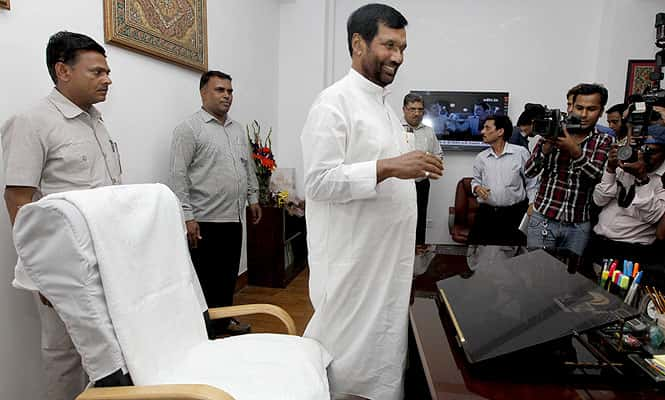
[13,184,331,400]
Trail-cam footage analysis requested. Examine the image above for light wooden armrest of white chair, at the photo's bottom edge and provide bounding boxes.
[76,385,234,400]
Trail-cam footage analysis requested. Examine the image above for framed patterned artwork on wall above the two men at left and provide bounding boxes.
[102,0,208,71]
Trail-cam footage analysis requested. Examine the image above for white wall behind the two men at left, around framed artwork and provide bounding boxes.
[0,0,280,399]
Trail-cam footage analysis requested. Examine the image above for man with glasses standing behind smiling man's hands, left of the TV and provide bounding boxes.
[402,93,442,248]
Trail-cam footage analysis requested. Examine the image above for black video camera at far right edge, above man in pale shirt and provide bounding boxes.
[617,13,665,163]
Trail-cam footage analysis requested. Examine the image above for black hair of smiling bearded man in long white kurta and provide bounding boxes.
[346,4,408,55]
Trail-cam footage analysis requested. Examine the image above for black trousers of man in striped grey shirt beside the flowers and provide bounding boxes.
[189,222,242,326]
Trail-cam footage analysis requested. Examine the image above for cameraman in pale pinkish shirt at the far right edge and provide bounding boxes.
[589,125,665,263]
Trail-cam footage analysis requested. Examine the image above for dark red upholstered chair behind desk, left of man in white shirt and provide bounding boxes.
[448,177,478,244]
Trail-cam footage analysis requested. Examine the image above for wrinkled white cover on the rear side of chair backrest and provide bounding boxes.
[14,199,126,382]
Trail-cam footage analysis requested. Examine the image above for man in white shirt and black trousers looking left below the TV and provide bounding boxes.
[469,115,537,244]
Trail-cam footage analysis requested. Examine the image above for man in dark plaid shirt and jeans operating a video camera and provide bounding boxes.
[525,84,612,256]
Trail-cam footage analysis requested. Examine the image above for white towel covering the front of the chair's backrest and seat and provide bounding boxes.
[39,185,331,400]
